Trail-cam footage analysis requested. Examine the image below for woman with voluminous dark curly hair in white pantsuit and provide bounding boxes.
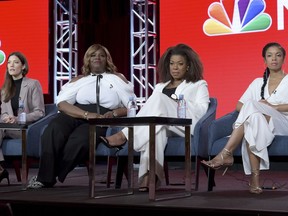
[102,44,209,192]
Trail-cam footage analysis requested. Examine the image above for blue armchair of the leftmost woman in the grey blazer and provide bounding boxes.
[2,104,58,182]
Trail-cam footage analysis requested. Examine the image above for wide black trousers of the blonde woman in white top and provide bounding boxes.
[37,113,107,186]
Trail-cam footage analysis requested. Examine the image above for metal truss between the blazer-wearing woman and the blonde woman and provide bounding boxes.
[54,0,78,101]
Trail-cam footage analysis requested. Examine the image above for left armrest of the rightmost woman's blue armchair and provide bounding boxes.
[208,110,239,153]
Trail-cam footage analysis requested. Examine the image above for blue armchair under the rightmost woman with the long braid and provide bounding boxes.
[208,111,288,191]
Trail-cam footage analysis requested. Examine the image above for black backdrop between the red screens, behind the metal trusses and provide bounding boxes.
[45,0,130,103]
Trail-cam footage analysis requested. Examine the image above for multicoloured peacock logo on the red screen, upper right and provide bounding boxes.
[203,0,272,36]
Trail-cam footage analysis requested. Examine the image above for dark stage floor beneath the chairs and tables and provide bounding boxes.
[0,164,288,216]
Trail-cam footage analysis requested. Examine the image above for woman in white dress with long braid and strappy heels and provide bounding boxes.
[202,42,288,194]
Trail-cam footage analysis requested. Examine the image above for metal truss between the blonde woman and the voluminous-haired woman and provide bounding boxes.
[130,0,157,105]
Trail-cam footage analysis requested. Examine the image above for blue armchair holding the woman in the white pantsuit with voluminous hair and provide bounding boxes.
[111,97,217,190]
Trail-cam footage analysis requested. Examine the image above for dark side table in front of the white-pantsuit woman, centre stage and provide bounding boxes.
[89,116,192,201]
